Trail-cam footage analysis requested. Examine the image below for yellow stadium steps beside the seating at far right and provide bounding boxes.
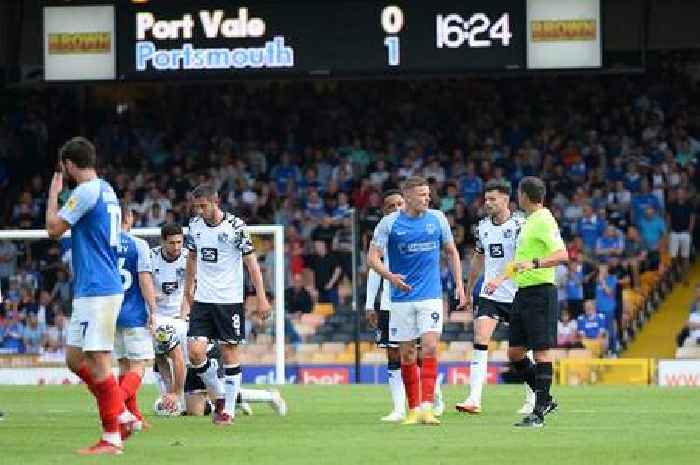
[622,260,700,359]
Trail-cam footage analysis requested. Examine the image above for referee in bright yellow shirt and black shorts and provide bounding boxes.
[487,176,569,428]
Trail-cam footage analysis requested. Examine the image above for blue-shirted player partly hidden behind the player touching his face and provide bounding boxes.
[114,203,156,430]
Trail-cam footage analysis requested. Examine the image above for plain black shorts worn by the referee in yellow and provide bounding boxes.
[508,284,559,350]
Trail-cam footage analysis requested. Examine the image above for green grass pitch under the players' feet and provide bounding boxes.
[0,386,700,465]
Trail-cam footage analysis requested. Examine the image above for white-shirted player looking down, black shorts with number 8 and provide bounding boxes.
[182,184,271,425]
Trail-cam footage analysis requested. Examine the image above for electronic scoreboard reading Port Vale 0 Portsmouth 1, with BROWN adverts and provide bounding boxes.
[44,0,602,81]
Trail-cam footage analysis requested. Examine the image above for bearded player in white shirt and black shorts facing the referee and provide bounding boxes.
[455,180,534,414]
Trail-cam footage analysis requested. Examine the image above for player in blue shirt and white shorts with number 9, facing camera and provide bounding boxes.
[367,176,467,425]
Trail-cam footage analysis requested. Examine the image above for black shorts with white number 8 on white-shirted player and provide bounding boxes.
[187,301,245,344]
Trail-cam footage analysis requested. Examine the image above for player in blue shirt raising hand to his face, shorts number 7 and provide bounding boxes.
[46,137,134,455]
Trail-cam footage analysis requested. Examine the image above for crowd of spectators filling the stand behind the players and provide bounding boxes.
[0,54,700,352]
